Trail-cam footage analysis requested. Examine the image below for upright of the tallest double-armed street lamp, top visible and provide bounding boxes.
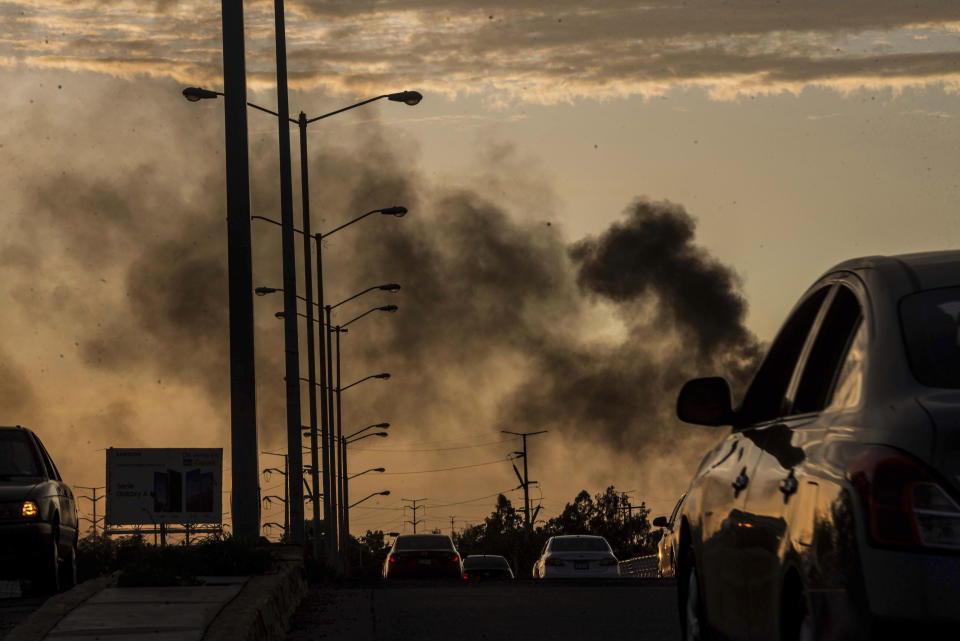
[297,111,322,559]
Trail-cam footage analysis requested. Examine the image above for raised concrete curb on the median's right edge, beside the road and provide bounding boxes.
[203,548,307,641]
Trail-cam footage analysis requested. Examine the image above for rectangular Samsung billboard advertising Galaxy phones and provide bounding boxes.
[106,447,223,525]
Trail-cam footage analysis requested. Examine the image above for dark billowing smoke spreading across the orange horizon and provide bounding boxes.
[0,70,759,527]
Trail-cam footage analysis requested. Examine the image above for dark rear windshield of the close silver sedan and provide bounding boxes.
[900,287,960,388]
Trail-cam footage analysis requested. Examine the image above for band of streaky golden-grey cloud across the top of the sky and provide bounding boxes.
[0,0,960,104]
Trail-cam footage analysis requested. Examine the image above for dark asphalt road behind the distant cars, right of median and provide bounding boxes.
[287,580,680,641]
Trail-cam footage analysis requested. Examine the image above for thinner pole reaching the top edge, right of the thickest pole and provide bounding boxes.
[273,0,303,544]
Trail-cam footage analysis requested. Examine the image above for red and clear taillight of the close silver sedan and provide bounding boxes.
[848,446,960,548]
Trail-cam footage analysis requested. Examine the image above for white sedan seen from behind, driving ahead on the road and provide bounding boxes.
[533,534,620,579]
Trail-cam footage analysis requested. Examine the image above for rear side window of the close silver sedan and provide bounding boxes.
[791,285,863,414]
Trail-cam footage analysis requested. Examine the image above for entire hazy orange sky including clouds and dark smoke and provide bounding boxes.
[0,0,960,534]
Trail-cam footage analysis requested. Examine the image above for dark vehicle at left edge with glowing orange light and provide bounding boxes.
[0,426,78,592]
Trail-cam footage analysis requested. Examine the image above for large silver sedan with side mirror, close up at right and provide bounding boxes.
[677,251,960,641]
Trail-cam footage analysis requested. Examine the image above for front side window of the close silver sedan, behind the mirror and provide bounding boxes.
[738,286,830,426]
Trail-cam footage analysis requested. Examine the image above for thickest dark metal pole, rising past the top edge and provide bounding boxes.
[221,0,260,541]
